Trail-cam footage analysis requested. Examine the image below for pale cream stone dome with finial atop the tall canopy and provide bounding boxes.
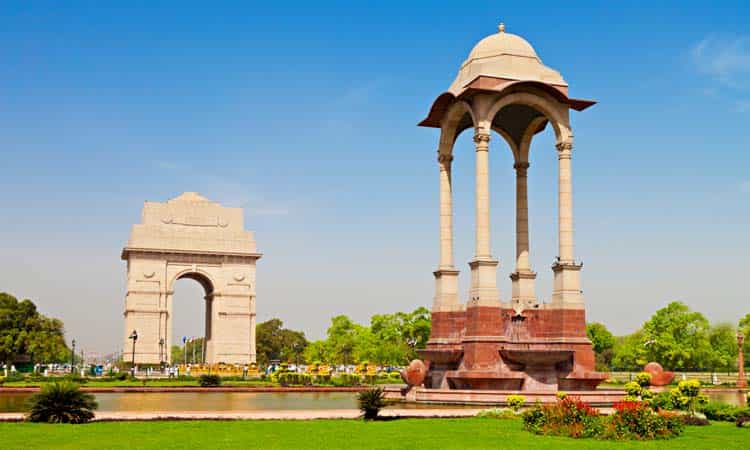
[450,24,567,95]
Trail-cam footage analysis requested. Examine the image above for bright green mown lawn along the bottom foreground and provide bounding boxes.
[0,419,750,450]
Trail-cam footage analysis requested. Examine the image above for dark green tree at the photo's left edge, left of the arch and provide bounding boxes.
[0,292,70,364]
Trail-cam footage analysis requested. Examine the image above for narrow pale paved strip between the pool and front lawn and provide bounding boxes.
[0,408,482,422]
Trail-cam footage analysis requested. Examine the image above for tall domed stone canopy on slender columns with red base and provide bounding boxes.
[417,24,606,401]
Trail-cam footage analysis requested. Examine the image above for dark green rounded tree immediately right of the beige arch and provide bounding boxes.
[255,319,307,366]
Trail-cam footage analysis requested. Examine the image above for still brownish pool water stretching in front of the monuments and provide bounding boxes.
[0,391,745,412]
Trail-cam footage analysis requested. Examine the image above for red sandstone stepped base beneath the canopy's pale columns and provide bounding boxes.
[420,304,607,392]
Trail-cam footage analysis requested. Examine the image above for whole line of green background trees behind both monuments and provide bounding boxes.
[0,293,750,371]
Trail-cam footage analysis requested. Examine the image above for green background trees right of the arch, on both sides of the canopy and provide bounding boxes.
[257,302,750,371]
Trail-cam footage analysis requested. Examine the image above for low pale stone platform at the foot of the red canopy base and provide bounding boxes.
[386,387,625,407]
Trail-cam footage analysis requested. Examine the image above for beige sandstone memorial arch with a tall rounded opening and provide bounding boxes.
[122,192,262,364]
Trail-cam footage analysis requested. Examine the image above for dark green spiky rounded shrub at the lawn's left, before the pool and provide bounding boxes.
[27,381,99,423]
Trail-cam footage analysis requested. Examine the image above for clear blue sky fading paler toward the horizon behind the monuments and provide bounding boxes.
[0,1,750,352]
